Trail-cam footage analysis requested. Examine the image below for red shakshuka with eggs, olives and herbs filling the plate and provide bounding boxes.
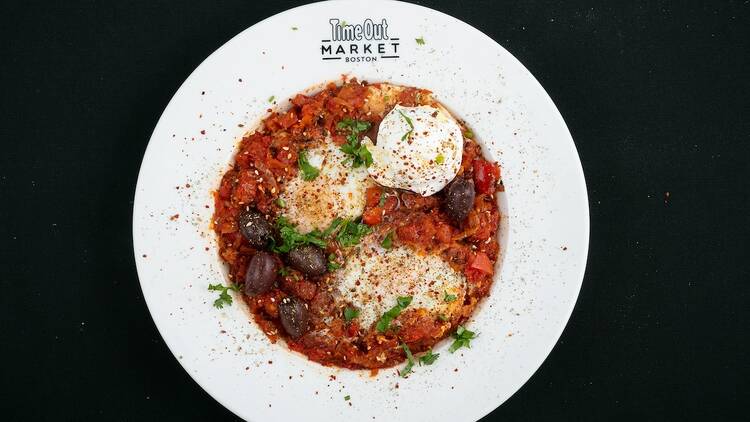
[213,79,503,376]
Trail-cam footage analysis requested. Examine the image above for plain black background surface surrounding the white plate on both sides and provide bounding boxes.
[0,0,750,421]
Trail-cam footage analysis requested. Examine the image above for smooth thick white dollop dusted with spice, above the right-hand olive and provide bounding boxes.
[362,105,463,196]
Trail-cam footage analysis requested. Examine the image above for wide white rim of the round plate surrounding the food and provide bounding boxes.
[133,1,589,422]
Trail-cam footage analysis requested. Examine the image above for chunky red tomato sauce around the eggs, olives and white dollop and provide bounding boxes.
[213,80,502,368]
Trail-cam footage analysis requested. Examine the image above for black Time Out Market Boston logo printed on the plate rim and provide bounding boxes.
[320,18,399,62]
